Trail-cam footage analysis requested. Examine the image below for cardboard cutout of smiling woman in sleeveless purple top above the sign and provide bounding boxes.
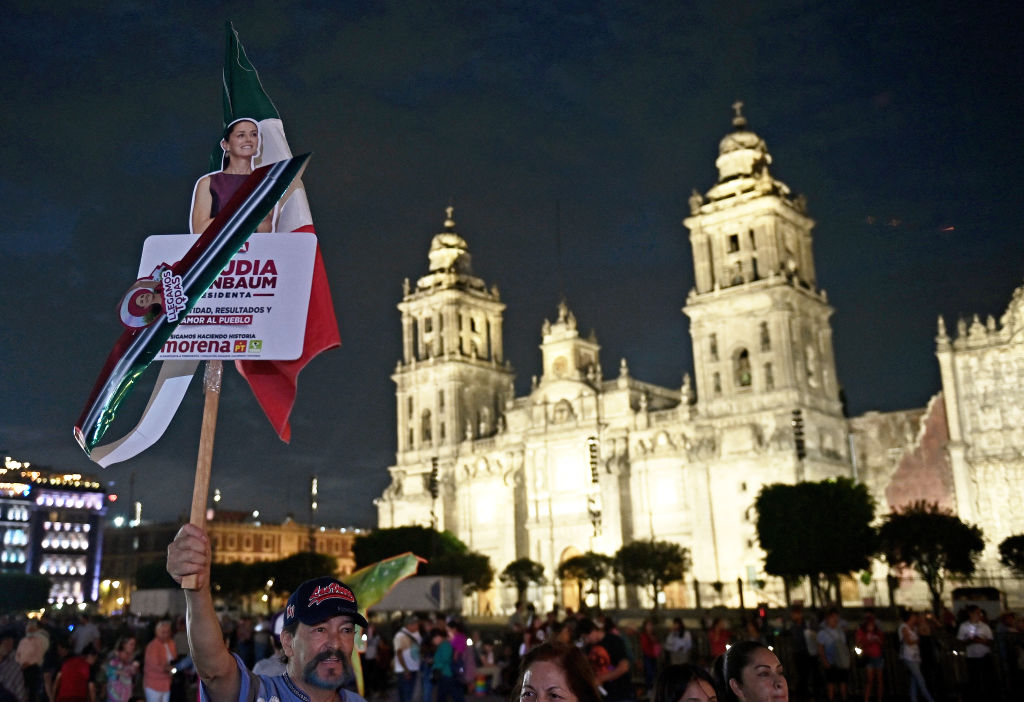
[188,118,276,234]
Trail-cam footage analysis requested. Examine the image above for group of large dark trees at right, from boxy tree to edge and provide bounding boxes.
[755,478,1024,611]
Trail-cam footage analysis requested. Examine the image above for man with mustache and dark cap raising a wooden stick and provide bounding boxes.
[167,524,367,702]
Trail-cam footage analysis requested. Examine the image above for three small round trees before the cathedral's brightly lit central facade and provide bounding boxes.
[500,540,691,609]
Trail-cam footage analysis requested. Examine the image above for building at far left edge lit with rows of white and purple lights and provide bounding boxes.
[0,456,105,604]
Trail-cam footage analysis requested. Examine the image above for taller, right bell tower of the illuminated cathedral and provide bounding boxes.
[683,102,848,479]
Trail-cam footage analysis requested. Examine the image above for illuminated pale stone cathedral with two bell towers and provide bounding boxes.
[376,104,1024,608]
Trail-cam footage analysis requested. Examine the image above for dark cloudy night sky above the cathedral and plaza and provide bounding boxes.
[0,0,1024,526]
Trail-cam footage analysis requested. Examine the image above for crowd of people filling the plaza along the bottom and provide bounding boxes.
[0,569,1024,702]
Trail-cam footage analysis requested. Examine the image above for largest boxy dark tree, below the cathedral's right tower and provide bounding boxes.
[754,478,878,602]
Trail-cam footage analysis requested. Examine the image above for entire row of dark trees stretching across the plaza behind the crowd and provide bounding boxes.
[116,478,1024,609]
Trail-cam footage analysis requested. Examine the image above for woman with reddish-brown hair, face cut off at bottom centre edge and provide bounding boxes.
[510,642,601,702]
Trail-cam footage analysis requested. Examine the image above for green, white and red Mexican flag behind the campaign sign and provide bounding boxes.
[212,23,341,441]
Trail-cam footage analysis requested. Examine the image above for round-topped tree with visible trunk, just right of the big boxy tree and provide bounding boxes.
[879,500,985,614]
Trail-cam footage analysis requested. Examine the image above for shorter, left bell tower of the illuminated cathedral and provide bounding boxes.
[391,207,513,478]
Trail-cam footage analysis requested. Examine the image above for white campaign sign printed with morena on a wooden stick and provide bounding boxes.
[138,233,316,360]
